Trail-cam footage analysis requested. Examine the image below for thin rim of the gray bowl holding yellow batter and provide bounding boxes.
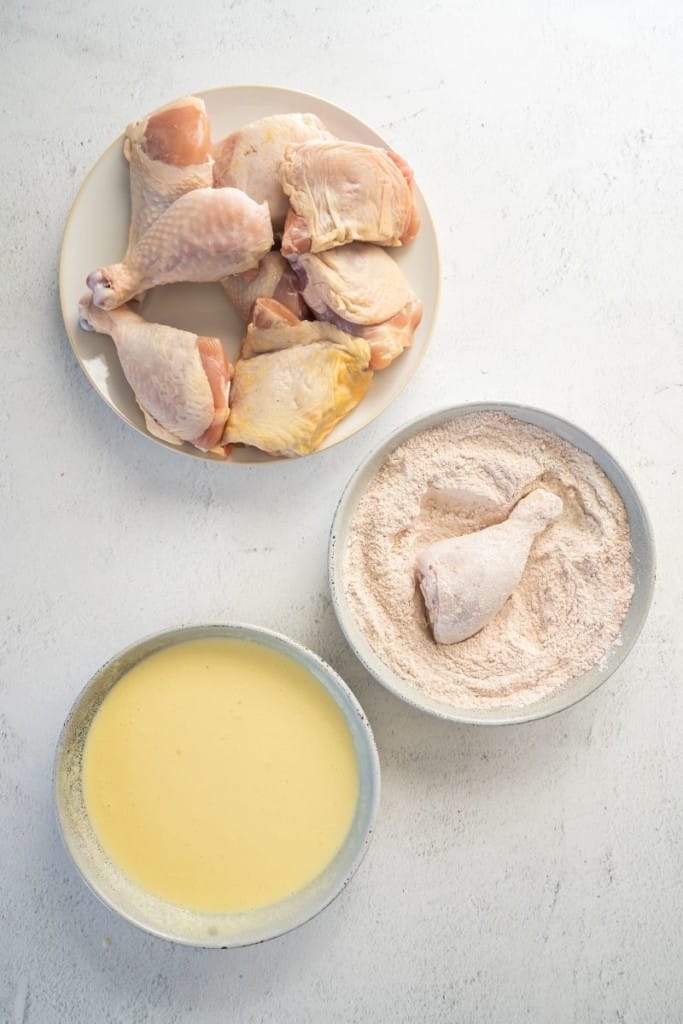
[52,622,381,949]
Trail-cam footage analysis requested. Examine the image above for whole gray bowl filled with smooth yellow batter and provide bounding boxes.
[54,625,380,947]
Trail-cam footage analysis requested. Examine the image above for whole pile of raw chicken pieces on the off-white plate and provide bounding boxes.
[80,96,422,456]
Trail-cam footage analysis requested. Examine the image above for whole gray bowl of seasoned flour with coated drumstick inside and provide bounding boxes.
[330,403,654,725]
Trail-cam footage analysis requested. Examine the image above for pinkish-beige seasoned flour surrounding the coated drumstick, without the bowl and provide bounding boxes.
[344,413,633,708]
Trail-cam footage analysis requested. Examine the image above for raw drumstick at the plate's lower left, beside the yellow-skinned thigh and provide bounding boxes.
[79,294,233,456]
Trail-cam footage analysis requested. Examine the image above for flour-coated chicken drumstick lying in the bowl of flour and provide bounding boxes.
[417,487,563,644]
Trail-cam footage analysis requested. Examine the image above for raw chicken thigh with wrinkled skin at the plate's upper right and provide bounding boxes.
[281,141,420,257]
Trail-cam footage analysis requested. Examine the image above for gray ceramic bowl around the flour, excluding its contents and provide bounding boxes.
[329,402,654,725]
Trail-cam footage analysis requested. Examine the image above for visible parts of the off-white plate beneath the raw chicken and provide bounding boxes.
[59,85,440,462]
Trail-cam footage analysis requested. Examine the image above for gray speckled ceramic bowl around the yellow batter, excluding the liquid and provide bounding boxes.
[54,625,380,948]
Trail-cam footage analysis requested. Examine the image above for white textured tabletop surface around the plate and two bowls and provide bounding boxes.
[0,0,683,1024]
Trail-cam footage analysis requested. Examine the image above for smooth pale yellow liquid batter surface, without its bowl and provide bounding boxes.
[83,638,358,911]
